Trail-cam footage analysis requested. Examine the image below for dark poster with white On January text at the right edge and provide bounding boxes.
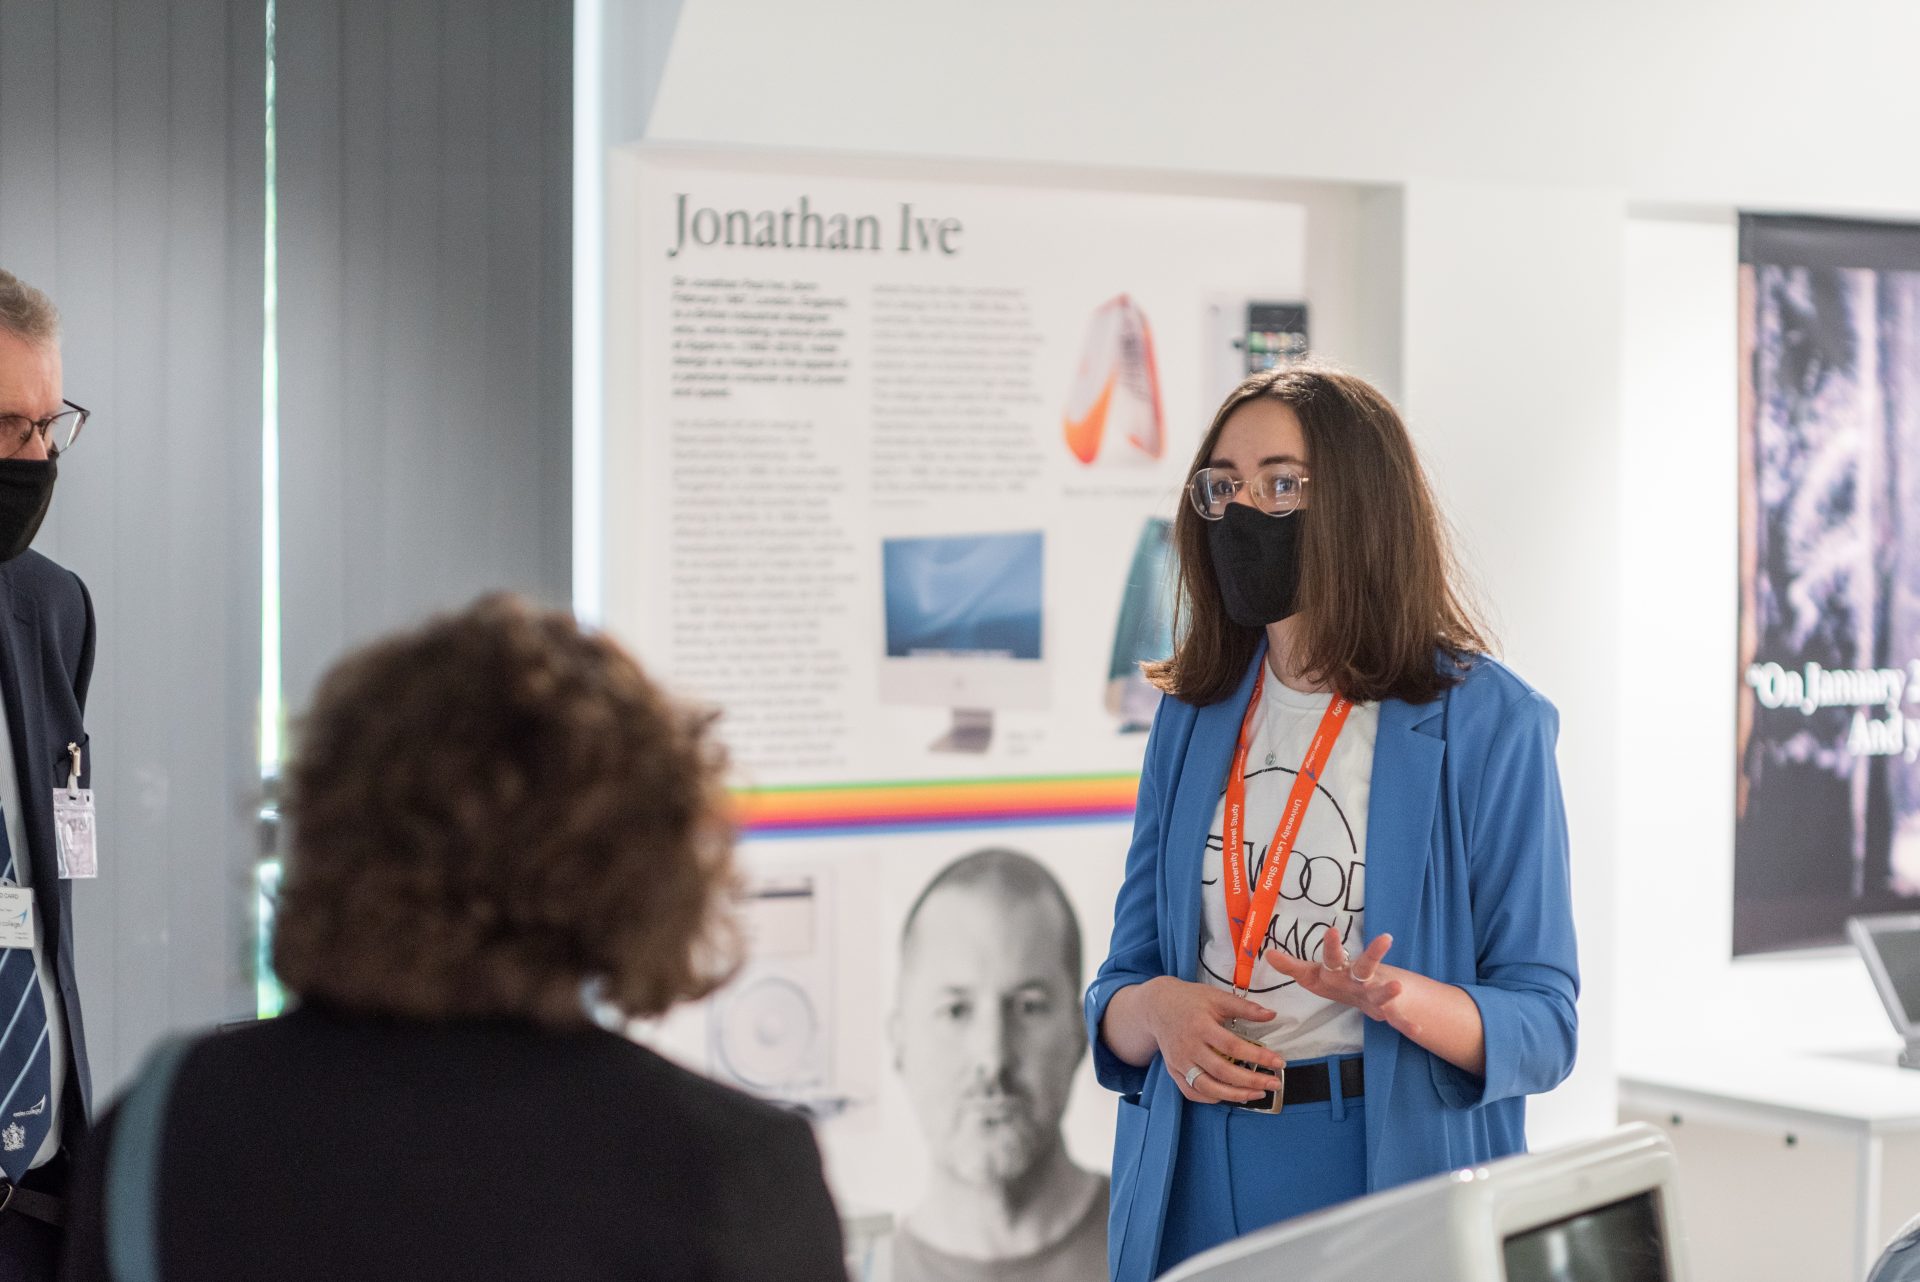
[1734,215,1920,954]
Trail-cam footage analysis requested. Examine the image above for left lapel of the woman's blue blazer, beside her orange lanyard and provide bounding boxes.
[1160,641,1267,981]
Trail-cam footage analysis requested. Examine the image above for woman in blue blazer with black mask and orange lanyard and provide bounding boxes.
[1087,367,1578,1282]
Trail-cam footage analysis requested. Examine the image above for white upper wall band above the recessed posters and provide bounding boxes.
[648,0,1920,211]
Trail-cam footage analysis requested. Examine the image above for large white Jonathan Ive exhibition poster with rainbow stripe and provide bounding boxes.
[605,148,1308,1258]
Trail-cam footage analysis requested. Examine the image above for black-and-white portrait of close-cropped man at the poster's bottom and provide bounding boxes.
[889,848,1108,1282]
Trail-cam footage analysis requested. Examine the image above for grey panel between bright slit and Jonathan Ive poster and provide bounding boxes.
[278,0,572,710]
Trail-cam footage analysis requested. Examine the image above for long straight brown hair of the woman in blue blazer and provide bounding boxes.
[1144,365,1492,704]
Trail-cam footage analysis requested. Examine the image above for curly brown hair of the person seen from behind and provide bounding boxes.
[273,595,739,1027]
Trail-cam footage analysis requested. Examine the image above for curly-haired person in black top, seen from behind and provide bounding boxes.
[65,597,847,1282]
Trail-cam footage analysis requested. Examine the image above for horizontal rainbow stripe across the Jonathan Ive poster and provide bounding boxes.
[733,773,1140,839]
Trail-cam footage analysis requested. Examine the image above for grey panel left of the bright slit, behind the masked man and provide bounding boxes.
[0,0,265,1098]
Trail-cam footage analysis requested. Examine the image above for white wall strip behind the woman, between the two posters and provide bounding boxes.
[1402,182,1622,1144]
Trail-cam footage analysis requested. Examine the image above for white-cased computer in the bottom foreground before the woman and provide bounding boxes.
[1162,1125,1688,1282]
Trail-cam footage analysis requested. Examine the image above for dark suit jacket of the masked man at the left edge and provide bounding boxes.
[0,551,94,1146]
